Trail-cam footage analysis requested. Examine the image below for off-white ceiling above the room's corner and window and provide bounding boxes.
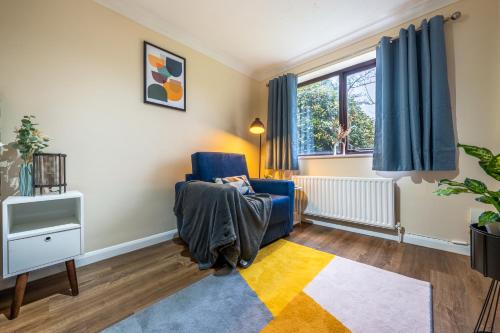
[95,0,456,80]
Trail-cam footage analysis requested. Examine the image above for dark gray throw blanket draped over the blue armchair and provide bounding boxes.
[174,181,272,269]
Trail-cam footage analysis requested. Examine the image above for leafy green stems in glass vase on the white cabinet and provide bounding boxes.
[14,115,49,196]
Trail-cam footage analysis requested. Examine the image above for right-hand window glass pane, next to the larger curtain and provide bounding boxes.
[346,67,375,150]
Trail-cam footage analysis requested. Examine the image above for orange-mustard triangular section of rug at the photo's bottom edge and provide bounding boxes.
[261,292,351,333]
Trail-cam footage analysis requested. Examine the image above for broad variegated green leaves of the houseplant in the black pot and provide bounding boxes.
[434,144,500,235]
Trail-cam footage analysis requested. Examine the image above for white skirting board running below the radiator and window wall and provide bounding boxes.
[307,218,470,256]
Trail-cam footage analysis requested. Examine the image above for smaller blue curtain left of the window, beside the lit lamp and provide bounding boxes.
[266,74,299,170]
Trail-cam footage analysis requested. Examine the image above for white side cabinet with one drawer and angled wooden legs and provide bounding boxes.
[2,191,84,319]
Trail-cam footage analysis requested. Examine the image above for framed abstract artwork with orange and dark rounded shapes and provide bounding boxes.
[144,42,186,111]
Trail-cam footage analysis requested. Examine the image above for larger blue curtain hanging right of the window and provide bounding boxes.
[373,16,456,171]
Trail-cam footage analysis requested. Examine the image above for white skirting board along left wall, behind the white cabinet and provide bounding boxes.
[0,229,177,290]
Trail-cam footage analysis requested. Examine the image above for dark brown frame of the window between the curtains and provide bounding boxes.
[297,59,377,157]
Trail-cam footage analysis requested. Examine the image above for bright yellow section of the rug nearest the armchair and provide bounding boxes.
[240,239,335,316]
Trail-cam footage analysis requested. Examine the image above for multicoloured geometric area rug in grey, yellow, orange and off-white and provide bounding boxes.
[104,240,432,333]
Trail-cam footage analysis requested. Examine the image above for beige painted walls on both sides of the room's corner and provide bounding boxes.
[0,0,500,258]
